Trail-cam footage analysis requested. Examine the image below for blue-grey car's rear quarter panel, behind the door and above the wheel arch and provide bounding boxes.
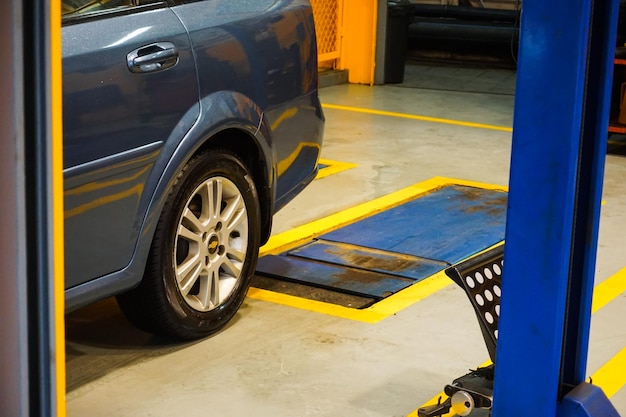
[172,0,323,206]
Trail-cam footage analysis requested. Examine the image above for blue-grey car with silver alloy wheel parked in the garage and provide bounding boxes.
[62,0,324,339]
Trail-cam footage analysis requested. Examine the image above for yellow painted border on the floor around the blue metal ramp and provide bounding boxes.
[248,177,506,323]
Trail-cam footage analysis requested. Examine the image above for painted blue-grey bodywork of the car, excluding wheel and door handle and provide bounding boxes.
[63,0,324,311]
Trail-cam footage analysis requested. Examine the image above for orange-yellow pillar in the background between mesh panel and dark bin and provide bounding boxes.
[337,0,378,85]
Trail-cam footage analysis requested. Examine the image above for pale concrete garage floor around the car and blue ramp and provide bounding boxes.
[67,62,626,417]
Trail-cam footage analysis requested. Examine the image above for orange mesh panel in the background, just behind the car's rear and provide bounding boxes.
[311,0,343,62]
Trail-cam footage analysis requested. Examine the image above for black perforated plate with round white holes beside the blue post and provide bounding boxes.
[446,245,504,362]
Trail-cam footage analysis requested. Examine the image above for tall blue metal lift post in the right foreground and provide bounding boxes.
[493,0,619,417]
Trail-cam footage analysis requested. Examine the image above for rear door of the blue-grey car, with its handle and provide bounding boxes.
[62,0,198,288]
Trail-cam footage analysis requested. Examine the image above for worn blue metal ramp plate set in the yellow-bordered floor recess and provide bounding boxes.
[251,185,507,305]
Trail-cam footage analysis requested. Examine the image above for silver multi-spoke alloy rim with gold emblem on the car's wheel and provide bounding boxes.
[174,177,248,312]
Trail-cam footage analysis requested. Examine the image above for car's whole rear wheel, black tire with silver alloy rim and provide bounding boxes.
[117,150,261,339]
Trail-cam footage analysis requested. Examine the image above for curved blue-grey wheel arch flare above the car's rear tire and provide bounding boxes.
[144,91,277,256]
